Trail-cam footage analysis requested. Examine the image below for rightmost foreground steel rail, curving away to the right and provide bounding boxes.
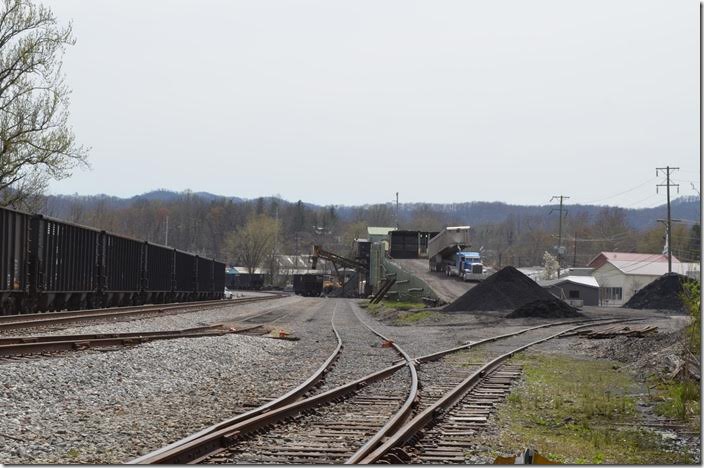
[357,319,630,464]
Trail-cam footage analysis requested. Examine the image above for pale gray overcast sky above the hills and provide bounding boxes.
[45,0,700,207]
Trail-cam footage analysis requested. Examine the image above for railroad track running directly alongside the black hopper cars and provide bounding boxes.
[0,294,282,331]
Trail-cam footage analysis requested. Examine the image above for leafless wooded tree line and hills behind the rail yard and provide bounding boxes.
[27,192,701,268]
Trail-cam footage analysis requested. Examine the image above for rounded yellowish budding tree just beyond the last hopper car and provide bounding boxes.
[224,214,279,275]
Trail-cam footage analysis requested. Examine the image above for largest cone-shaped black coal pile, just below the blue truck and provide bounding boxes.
[443,266,566,312]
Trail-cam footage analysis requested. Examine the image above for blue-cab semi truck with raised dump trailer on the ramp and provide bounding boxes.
[428,226,487,281]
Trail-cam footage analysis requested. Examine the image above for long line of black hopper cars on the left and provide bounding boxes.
[0,208,225,315]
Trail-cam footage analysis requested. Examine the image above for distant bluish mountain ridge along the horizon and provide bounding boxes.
[43,189,700,230]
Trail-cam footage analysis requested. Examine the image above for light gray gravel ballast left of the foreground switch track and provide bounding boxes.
[0,301,335,464]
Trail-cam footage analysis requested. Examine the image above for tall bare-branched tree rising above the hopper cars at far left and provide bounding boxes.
[0,0,87,206]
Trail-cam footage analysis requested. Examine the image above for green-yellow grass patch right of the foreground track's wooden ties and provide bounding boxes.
[490,354,691,464]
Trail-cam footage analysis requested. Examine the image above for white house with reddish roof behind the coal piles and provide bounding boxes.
[589,252,699,307]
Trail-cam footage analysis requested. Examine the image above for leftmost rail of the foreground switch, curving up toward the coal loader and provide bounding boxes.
[127,304,343,465]
